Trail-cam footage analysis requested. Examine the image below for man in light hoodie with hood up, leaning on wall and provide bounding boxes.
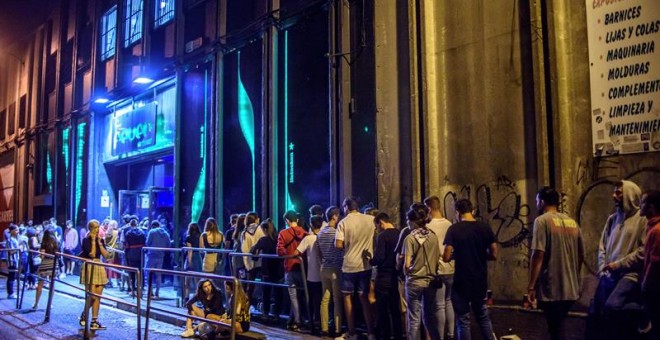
[590,180,647,339]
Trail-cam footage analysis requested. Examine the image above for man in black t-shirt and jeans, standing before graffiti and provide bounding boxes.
[442,199,497,340]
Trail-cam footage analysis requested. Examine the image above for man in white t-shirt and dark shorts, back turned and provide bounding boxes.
[335,198,376,340]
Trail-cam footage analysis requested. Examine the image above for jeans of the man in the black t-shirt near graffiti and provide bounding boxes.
[451,290,496,340]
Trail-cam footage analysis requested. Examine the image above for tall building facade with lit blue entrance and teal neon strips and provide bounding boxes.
[0,0,660,301]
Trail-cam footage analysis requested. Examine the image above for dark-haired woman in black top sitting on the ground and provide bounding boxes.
[181,279,225,338]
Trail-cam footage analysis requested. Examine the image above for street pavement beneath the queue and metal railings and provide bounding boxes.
[0,276,584,340]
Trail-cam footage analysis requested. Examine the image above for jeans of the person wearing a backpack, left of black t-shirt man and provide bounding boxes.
[406,280,445,340]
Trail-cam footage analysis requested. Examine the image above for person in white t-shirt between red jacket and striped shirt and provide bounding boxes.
[296,216,323,334]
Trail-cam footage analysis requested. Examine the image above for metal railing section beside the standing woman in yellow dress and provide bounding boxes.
[55,252,142,340]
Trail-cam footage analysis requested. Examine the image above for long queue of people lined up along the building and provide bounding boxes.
[5,181,660,340]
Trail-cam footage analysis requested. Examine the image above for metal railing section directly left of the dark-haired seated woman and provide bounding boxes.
[144,268,240,340]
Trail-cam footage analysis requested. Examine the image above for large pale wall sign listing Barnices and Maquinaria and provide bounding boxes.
[586,0,660,156]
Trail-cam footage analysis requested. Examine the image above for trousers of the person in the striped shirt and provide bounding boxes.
[321,267,344,334]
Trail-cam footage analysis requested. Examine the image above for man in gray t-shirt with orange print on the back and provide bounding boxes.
[528,187,584,340]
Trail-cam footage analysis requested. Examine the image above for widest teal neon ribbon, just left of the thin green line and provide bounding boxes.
[238,51,257,210]
